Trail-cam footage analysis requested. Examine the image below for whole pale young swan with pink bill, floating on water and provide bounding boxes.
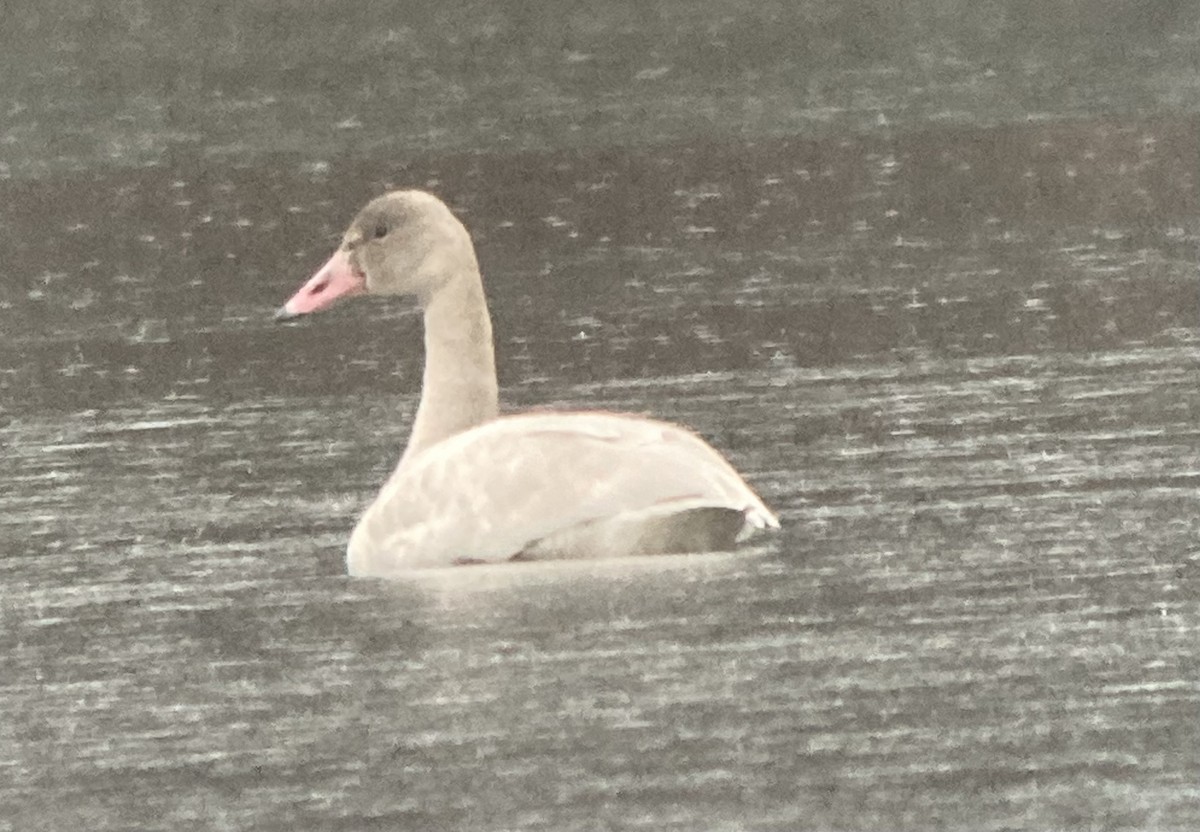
[276,190,779,577]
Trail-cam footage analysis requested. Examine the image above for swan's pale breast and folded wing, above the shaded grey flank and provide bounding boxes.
[349,413,779,574]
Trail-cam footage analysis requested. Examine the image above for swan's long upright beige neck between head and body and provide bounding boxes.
[398,247,499,468]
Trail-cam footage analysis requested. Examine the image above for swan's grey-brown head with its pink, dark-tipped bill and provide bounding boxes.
[275,191,475,319]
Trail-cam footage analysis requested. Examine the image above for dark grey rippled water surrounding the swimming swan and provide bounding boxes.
[0,1,1200,830]
